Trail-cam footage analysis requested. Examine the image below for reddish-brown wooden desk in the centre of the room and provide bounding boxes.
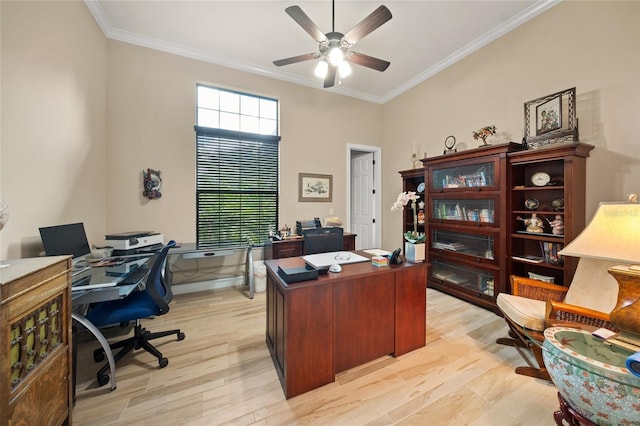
[265,257,428,398]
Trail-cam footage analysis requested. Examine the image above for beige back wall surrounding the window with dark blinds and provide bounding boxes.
[107,41,382,245]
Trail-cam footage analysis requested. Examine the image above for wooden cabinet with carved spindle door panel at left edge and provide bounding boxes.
[0,256,73,425]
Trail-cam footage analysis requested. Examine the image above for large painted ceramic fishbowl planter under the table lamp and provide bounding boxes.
[542,327,640,425]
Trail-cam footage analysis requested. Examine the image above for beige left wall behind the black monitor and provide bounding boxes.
[0,1,107,259]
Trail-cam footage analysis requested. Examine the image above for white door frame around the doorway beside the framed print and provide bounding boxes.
[346,143,382,248]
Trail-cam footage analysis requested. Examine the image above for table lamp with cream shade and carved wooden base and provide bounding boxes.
[558,200,640,351]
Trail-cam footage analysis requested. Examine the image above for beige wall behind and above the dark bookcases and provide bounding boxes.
[382,1,640,247]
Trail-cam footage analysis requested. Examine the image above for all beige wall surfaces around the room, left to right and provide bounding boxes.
[0,1,640,258]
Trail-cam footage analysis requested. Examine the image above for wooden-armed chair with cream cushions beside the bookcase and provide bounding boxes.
[496,258,618,380]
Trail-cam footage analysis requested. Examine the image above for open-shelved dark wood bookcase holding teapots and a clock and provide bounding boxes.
[507,143,593,285]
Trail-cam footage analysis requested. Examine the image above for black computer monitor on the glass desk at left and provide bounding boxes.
[40,223,91,263]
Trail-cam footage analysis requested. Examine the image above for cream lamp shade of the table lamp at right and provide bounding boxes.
[558,203,640,263]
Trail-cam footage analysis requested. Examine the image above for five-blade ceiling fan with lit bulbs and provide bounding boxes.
[273,0,391,88]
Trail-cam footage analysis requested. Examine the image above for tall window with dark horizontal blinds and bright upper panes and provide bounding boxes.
[195,85,280,247]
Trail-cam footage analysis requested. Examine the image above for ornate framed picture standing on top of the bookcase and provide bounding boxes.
[523,87,578,149]
